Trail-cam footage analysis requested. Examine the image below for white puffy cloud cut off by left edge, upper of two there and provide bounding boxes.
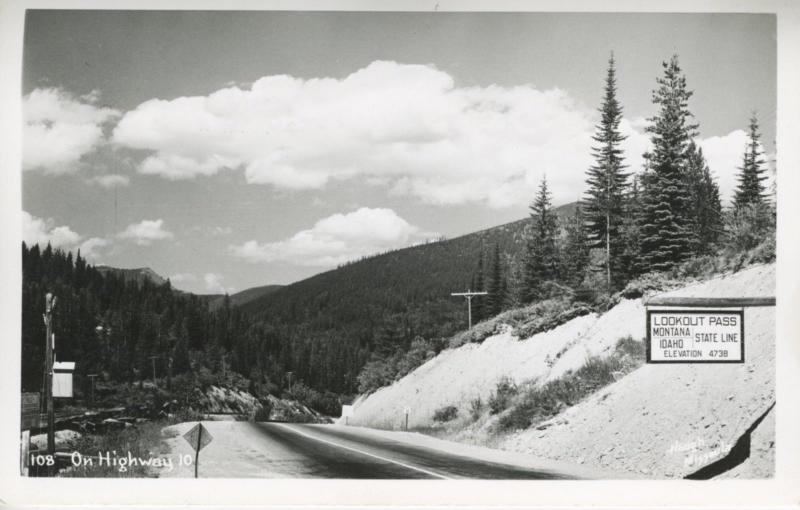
[22,88,119,174]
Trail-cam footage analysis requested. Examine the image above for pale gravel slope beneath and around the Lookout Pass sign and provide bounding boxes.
[500,265,775,477]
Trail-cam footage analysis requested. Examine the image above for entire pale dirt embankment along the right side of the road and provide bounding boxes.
[349,264,775,477]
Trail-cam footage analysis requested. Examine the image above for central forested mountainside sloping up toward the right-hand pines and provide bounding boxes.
[234,204,575,394]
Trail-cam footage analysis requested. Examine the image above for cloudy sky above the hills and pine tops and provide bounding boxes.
[22,10,776,293]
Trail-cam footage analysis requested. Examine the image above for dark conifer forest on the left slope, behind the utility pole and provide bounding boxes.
[22,243,368,393]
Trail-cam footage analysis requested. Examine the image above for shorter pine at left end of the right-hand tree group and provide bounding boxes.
[522,177,559,303]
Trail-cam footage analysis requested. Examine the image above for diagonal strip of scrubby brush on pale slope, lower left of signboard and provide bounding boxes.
[498,337,644,431]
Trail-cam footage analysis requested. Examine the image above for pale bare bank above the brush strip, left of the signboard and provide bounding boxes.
[348,299,645,430]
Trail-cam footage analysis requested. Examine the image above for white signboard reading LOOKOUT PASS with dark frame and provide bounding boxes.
[647,309,744,363]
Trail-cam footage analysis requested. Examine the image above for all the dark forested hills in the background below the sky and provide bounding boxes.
[22,204,574,404]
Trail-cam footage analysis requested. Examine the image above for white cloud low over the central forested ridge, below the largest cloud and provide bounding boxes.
[230,207,432,267]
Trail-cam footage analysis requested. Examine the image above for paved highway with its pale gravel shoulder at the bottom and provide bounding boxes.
[161,422,579,480]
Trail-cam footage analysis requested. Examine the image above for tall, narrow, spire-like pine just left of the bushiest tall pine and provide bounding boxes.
[583,54,629,290]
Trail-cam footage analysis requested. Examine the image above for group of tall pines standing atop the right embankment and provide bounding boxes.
[506,56,774,303]
